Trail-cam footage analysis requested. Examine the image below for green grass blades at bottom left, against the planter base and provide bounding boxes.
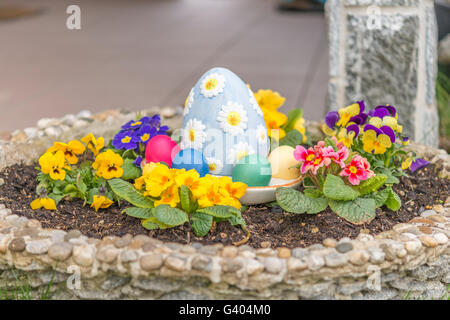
[0,269,56,300]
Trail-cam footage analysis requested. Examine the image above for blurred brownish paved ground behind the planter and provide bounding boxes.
[0,0,328,131]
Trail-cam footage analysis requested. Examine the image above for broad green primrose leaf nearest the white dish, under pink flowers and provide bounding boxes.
[276,188,328,214]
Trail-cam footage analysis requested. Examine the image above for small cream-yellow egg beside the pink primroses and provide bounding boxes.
[268,146,300,180]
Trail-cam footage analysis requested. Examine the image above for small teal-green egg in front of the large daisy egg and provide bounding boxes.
[232,154,272,187]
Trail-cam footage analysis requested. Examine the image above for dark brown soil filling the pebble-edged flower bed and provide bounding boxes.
[0,165,449,248]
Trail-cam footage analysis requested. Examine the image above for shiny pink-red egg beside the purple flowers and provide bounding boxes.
[145,135,180,167]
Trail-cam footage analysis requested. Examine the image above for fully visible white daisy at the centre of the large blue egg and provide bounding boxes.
[217,101,248,136]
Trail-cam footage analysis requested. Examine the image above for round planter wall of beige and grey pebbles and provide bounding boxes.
[0,109,450,299]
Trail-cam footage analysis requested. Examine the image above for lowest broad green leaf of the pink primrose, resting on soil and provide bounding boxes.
[330,198,376,224]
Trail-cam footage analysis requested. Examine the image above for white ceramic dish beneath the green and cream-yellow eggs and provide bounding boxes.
[239,177,302,205]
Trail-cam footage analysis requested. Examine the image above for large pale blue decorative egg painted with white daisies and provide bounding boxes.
[180,68,269,176]
